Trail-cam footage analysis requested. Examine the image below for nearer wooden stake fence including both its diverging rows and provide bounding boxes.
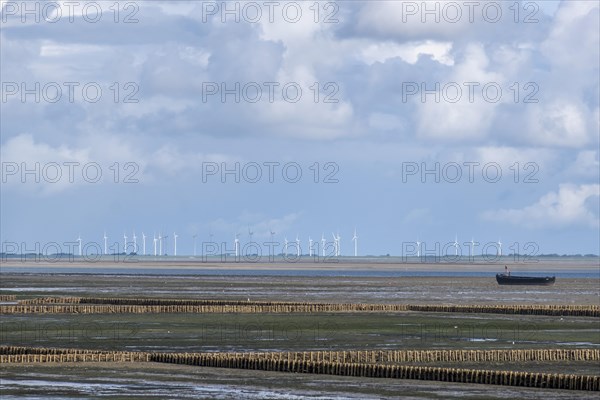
[0,346,600,391]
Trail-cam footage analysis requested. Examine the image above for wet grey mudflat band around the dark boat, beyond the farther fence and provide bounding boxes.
[0,273,600,305]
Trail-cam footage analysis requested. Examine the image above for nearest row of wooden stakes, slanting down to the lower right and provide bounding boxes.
[0,348,600,391]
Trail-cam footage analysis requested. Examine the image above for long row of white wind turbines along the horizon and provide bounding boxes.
[70,228,502,257]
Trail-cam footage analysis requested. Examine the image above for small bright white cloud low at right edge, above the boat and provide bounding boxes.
[482,184,600,228]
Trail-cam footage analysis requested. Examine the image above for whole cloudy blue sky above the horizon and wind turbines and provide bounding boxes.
[0,0,600,255]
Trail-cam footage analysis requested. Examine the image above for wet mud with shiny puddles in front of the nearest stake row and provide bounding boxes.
[0,363,597,400]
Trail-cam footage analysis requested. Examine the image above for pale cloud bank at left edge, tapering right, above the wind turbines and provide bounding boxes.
[0,134,237,195]
